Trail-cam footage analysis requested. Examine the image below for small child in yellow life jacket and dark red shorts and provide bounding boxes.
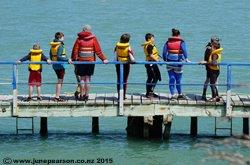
[18,44,50,101]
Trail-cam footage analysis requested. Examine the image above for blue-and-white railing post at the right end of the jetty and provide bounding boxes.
[226,65,232,116]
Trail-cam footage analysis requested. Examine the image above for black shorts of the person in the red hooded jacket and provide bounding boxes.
[76,64,95,76]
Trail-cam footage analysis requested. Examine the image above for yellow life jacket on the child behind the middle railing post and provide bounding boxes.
[115,42,129,62]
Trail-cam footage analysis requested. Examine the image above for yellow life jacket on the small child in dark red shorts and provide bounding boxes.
[29,49,43,71]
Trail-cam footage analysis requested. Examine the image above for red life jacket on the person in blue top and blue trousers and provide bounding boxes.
[167,37,183,54]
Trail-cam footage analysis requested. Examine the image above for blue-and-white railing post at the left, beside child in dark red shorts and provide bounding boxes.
[12,64,17,116]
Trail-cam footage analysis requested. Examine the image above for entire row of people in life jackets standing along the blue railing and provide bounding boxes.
[18,25,222,101]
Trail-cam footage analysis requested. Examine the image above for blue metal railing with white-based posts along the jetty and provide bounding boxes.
[0,61,250,116]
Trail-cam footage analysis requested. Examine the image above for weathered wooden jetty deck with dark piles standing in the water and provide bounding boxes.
[0,93,250,139]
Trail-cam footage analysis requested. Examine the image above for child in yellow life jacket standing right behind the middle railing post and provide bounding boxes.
[114,34,135,99]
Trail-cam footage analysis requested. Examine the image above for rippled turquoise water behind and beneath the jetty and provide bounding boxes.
[0,0,250,164]
